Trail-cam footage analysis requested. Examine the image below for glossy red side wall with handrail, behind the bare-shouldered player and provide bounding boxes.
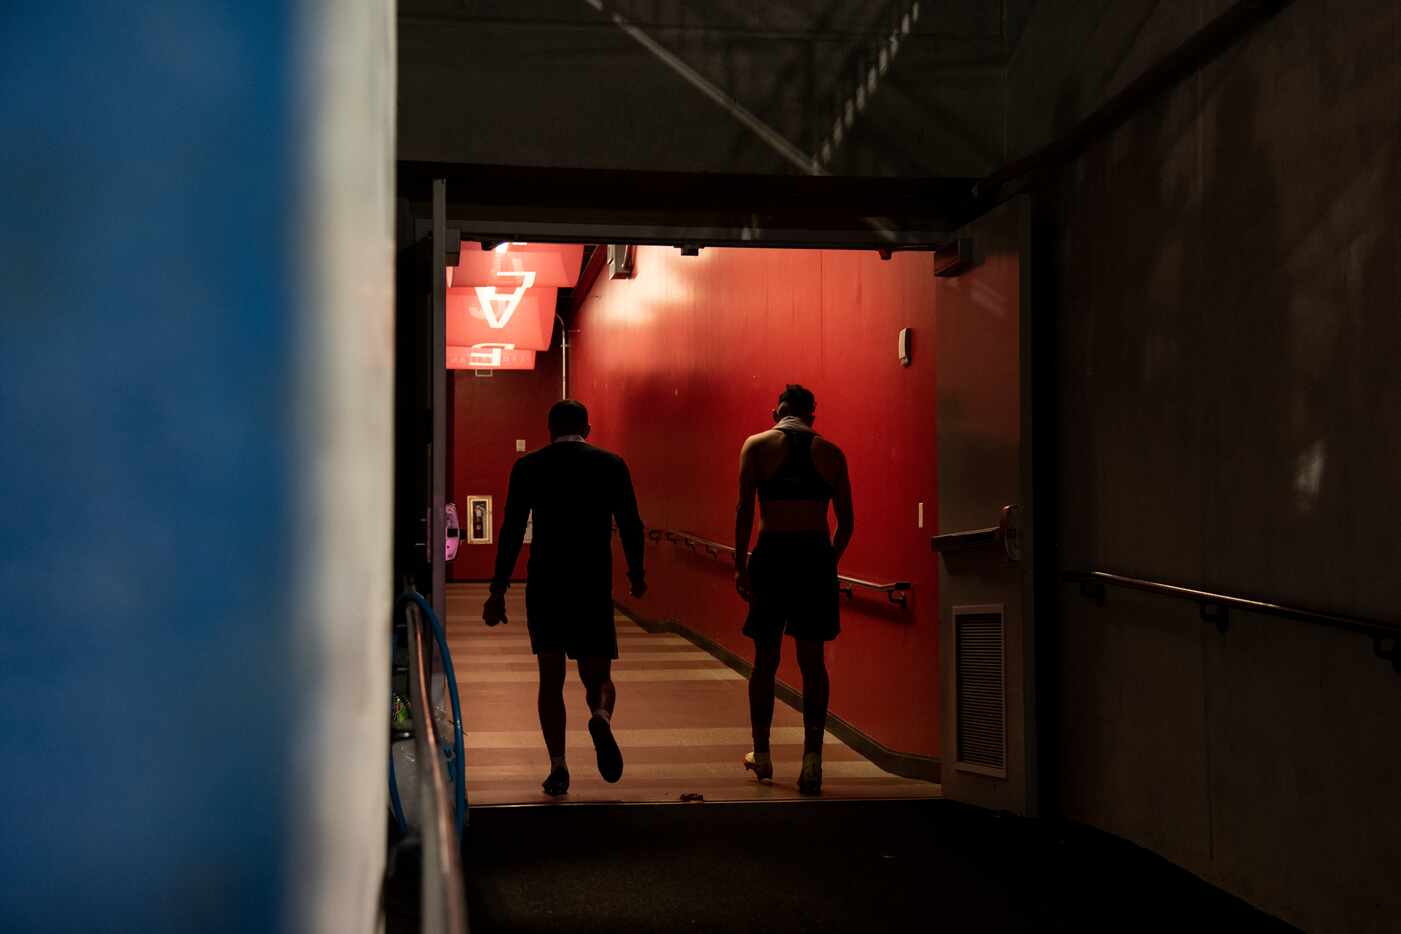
[570,246,939,756]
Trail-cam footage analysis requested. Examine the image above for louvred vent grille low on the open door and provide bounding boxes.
[954,606,1007,779]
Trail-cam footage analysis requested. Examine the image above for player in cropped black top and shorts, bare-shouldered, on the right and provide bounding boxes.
[734,384,853,794]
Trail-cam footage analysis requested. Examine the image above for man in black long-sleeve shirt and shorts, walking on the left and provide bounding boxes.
[482,399,647,795]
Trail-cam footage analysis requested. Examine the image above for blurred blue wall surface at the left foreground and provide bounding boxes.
[0,1,298,931]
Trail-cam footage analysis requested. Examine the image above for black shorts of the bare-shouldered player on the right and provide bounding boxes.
[744,532,842,641]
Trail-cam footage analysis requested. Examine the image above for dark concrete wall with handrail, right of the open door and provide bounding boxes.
[1007,0,1401,931]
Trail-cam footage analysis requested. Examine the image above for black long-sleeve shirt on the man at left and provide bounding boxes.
[492,441,644,613]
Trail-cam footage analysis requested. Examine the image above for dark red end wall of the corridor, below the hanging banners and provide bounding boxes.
[447,340,559,581]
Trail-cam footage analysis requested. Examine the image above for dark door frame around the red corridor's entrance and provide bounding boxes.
[398,161,1056,816]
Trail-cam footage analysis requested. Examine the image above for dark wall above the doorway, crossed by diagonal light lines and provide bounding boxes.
[398,0,1026,176]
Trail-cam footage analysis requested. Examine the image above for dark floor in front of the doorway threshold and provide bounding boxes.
[453,801,1292,934]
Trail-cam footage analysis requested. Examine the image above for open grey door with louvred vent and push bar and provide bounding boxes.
[932,199,1035,815]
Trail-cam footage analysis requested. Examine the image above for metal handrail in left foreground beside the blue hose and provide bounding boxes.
[405,604,467,934]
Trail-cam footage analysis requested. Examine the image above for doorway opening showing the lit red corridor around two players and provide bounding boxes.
[392,171,1020,805]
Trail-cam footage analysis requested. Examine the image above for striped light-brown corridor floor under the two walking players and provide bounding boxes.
[447,584,940,805]
